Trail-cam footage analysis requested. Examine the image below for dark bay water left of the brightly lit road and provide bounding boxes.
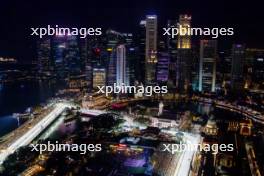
[0,81,58,137]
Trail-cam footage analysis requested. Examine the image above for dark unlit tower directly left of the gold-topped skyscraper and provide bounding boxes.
[167,20,177,86]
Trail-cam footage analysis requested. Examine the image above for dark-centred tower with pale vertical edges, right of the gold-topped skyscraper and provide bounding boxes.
[199,40,217,92]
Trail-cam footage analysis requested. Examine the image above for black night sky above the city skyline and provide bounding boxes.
[0,0,264,60]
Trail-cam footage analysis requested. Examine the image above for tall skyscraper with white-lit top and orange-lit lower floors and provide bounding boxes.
[145,15,157,84]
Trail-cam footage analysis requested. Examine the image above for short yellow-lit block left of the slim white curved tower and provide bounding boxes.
[93,68,106,89]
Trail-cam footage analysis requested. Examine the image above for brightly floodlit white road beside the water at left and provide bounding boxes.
[0,103,71,164]
